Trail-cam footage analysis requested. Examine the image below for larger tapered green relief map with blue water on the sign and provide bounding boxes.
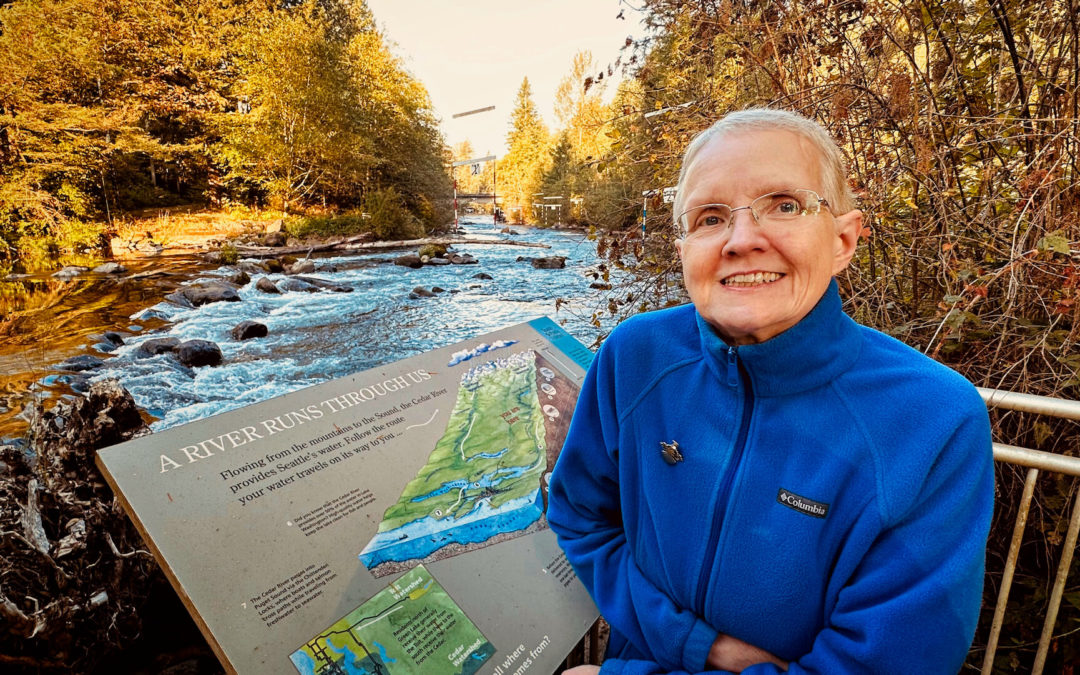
[360,345,578,577]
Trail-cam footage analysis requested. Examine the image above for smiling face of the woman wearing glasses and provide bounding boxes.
[675,131,862,345]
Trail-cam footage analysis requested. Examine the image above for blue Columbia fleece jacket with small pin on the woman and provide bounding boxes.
[548,282,994,675]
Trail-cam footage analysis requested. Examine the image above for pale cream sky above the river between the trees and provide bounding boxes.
[367,0,643,157]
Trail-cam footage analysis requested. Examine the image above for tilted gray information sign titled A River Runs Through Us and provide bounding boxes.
[97,319,597,675]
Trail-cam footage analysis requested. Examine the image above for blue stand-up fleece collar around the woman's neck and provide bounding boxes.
[694,279,862,396]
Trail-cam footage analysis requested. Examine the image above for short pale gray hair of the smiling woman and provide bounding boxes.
[672,108,855,230]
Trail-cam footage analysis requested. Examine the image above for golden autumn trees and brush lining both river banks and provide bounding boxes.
[0,0,1080,672]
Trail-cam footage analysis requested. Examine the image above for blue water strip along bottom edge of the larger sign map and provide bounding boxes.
[360,488,543,569]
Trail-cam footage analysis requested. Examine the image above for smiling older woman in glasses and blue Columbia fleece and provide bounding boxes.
[548,110,994,675]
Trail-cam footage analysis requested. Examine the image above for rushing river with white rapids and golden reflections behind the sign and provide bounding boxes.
[0,218,610,437]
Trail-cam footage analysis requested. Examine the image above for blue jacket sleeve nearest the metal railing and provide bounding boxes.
[743,402,994,675]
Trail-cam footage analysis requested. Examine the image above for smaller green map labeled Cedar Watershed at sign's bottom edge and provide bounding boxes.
[289,565,495,675]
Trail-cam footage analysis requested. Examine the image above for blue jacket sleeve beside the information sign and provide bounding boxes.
[548,336,717,671]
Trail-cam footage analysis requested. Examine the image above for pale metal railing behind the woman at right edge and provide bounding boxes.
[978,388,1080,675]
